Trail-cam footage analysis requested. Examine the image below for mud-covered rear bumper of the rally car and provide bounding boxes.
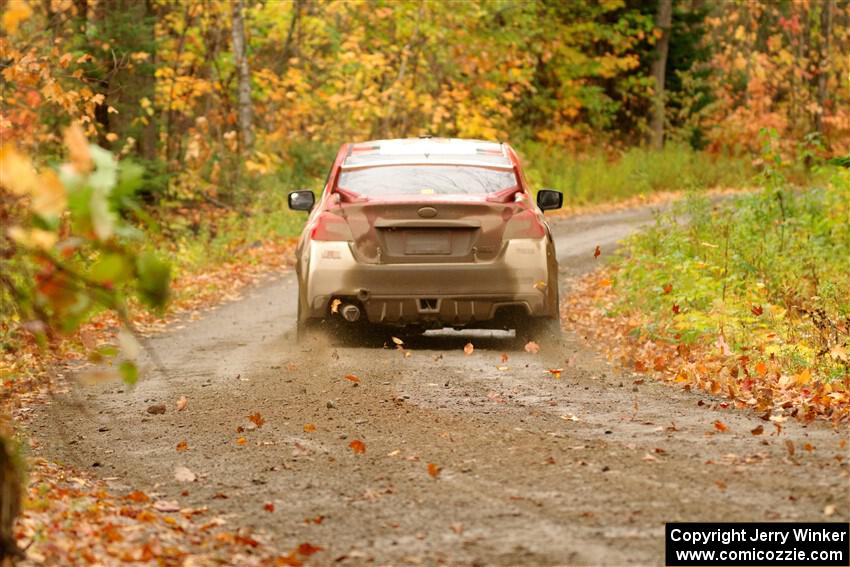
[300,238,558,326]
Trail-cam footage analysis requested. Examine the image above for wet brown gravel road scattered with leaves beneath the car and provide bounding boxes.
[32,209,850,565]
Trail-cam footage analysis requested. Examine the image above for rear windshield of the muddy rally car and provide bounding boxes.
[338,165,517,197]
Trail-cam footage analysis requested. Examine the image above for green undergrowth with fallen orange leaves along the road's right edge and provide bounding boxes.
[570,165,850,419]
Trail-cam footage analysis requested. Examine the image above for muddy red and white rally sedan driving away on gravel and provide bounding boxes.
[289,138,562,338]
